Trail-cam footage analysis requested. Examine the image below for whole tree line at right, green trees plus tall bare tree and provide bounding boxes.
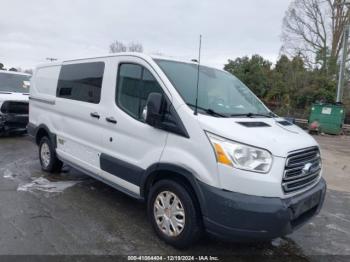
[224,0,350,117]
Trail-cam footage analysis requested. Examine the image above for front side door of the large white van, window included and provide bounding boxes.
[100,57,168,194]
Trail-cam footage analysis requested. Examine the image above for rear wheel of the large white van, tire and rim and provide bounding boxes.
[39,136,63,173]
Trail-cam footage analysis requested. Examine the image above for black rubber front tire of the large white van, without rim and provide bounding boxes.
[147,180,203,249]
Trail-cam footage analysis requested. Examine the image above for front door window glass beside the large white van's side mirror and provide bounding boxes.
[116,64,163,121]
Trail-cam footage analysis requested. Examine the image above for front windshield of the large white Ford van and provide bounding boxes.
[155,59,273,117]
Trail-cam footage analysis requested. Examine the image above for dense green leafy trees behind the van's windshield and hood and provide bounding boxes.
[224,55,336,117]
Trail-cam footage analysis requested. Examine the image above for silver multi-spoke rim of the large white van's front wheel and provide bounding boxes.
[153,191,185,237]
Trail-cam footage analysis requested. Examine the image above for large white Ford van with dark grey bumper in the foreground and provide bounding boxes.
[28,53,326,248]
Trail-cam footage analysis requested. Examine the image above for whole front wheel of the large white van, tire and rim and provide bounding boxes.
[147,180,202,249]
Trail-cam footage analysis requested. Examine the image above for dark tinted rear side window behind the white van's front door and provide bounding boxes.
[57,62,105,104]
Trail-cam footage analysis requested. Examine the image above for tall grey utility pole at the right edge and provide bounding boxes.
[336,0,350,103]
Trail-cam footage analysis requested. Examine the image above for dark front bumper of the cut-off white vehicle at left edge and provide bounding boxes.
[0,113,29,133]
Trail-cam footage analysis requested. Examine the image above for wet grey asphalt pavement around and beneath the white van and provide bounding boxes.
[0,136,350,261]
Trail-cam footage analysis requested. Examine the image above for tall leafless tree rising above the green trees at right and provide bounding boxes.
[282,0,350,69]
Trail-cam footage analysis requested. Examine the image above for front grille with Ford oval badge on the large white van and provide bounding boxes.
[282,147,322,193]
